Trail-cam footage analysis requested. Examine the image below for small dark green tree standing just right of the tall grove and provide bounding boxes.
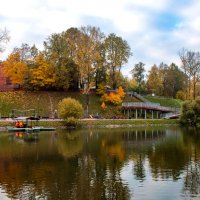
[131,62,145,94]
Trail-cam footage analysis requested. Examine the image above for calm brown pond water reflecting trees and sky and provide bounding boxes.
[0,127,200,200]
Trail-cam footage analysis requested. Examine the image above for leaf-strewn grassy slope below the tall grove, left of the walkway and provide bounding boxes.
[0,91,137,118]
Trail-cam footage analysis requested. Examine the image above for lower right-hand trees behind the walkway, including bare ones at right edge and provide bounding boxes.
[131,49,200,100]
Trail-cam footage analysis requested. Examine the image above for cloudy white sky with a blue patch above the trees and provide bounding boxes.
[0,0,200,76]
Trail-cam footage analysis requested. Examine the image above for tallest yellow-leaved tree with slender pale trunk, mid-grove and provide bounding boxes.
[76,26,103,113]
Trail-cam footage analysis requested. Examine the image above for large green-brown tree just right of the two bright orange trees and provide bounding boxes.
[44,32,78,90]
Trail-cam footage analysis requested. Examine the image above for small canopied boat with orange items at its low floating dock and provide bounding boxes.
[7,117,55,132]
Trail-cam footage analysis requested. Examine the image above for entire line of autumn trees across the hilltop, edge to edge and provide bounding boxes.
[0,26,200,100]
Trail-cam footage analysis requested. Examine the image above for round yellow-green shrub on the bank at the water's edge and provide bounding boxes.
[58,98,83,126]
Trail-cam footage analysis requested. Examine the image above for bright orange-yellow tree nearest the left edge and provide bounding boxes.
[2,52,27,85]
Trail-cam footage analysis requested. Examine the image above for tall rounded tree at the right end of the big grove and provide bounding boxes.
[104,33,131,89]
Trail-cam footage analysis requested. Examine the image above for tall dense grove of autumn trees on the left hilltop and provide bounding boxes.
[1,26,131,92]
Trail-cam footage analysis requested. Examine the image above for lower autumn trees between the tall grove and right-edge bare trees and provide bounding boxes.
[131,63,187,99]
